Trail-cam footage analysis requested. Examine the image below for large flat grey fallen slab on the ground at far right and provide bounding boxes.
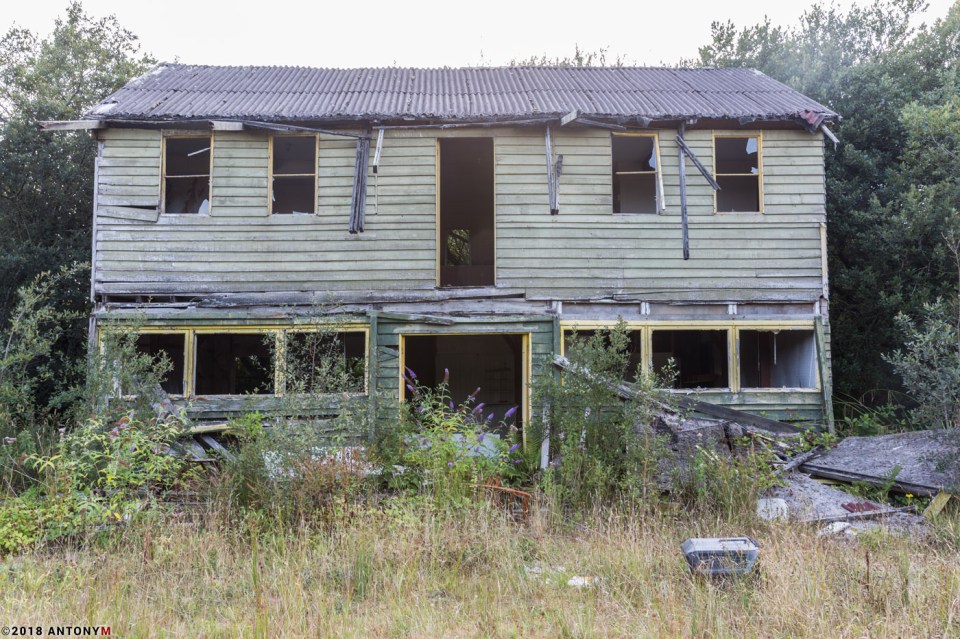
[800,430,960,497]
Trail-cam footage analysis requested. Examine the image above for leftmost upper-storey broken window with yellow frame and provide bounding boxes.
[163,136,212,213]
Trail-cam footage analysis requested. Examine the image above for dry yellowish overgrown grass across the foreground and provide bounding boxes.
[0,500,960,638]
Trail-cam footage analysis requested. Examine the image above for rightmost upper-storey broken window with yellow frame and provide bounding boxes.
[714,135,760,213]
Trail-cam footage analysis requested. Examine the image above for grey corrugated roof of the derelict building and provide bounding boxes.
[87,64,837,121]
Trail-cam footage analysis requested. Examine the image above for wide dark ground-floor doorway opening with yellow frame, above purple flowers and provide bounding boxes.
[403,335,524,426]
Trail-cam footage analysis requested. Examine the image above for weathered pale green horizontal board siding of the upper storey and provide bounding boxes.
[95,128,825,301]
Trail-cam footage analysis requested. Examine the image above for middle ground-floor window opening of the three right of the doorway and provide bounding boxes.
[652,330,730,388]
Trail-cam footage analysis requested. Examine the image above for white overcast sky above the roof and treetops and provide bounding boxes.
[0,0,954,67]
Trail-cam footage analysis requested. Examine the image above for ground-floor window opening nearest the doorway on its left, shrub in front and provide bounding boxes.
[284,331,366,393]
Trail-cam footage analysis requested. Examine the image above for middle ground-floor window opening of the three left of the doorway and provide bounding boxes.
[196,333,273,395]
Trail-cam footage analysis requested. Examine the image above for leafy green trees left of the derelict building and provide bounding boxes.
[0,1,154,416]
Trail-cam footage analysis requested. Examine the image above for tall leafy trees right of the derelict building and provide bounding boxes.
[692,0,960,412]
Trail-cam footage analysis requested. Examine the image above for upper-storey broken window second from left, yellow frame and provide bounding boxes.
[270,135,317,213]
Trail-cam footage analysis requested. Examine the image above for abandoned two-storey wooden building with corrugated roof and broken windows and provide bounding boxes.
[44,64,838,430]
